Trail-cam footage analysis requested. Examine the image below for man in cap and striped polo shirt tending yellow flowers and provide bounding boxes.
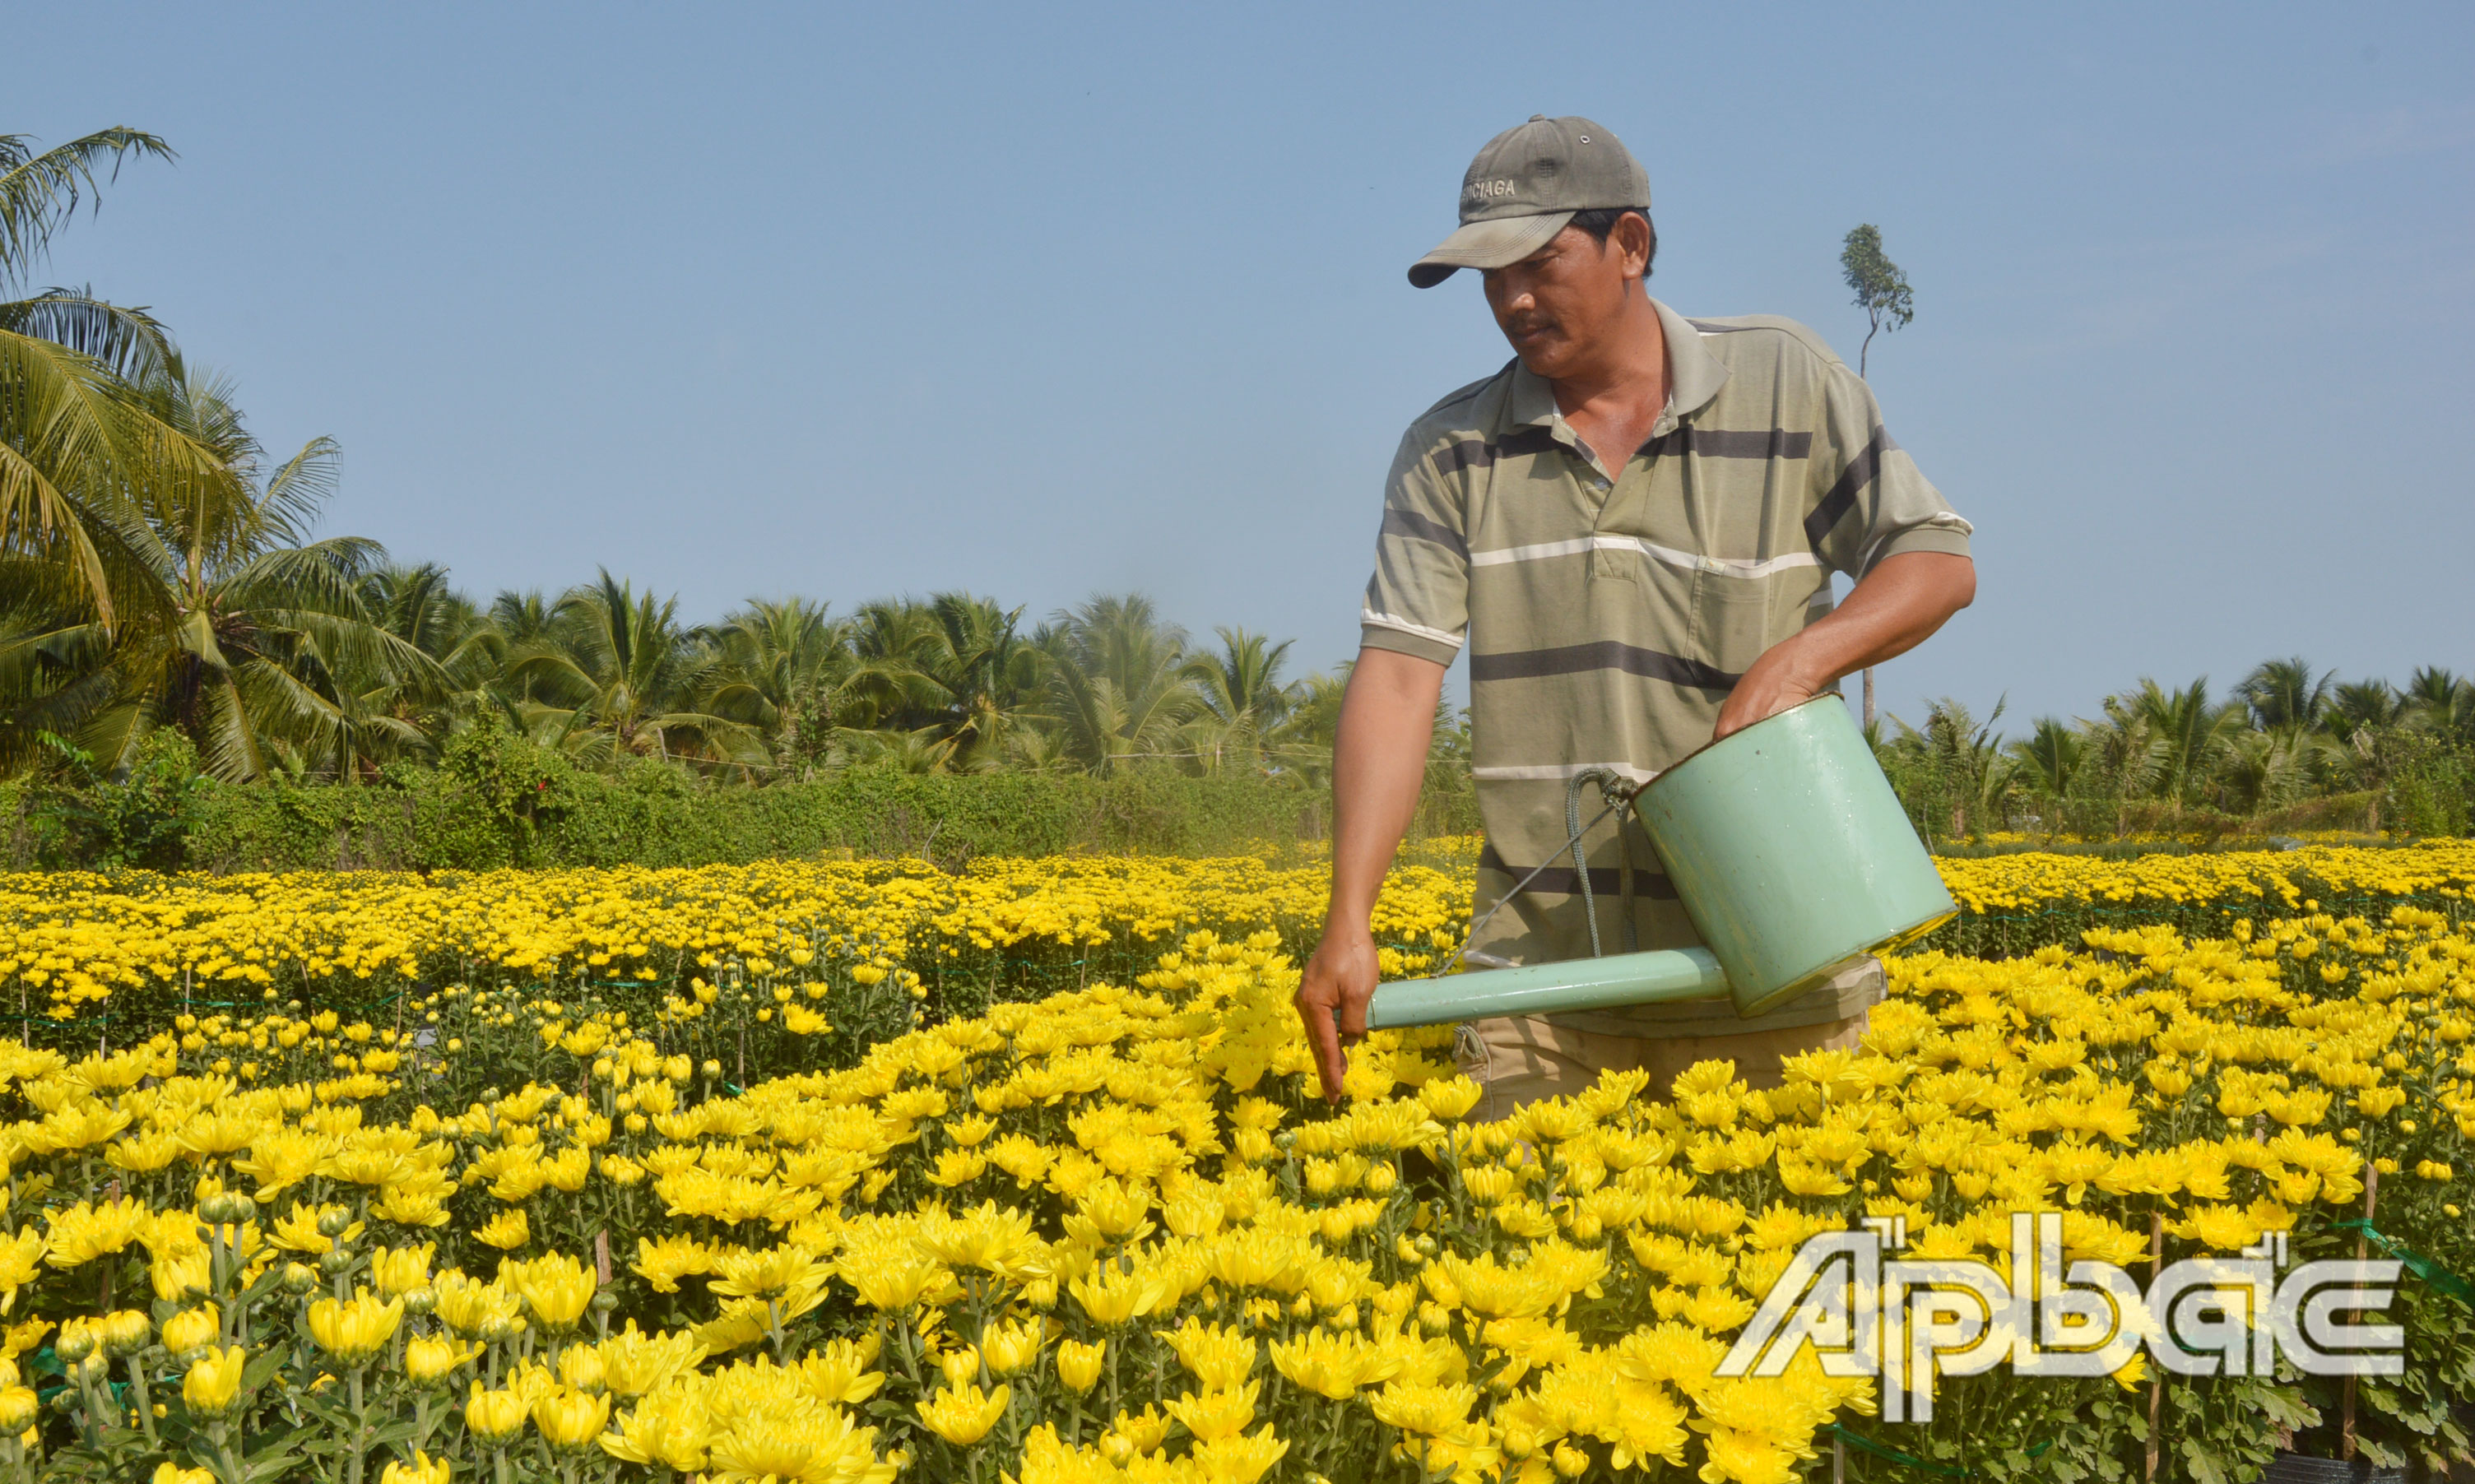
[1297,116,1975,1118]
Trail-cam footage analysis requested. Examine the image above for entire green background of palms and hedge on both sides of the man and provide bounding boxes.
[0,128,2475,865]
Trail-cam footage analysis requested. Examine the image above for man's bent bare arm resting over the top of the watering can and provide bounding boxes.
[1711,551,1977,737]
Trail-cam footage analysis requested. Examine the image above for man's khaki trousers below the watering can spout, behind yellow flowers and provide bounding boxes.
[1453,1014,1866,1123]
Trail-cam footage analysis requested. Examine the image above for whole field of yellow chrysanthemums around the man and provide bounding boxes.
[0,843,2475,1484]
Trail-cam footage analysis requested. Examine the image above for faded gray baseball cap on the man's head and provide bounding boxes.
[1409,114,1651,290]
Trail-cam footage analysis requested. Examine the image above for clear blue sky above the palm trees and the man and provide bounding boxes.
[19,0,2475,725]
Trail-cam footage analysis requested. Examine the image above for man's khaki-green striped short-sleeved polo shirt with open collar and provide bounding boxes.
[1361,299,1970,1036]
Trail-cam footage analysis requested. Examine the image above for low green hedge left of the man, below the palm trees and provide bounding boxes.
[0,732,1478,873]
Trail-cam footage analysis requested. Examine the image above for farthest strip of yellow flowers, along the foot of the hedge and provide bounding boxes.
[0,841,2475,1023]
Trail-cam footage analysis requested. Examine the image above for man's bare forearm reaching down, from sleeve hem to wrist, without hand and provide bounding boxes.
[1326,648,1443,928]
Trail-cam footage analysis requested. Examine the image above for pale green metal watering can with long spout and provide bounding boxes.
[1366,695,1960,1029]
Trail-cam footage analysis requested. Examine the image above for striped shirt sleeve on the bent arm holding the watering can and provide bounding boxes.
[1804,359,1975,582]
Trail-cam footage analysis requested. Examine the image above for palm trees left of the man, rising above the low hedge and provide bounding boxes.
[0,128,1453,816]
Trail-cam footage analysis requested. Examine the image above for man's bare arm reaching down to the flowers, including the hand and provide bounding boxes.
[1294,648,1443,1103]
